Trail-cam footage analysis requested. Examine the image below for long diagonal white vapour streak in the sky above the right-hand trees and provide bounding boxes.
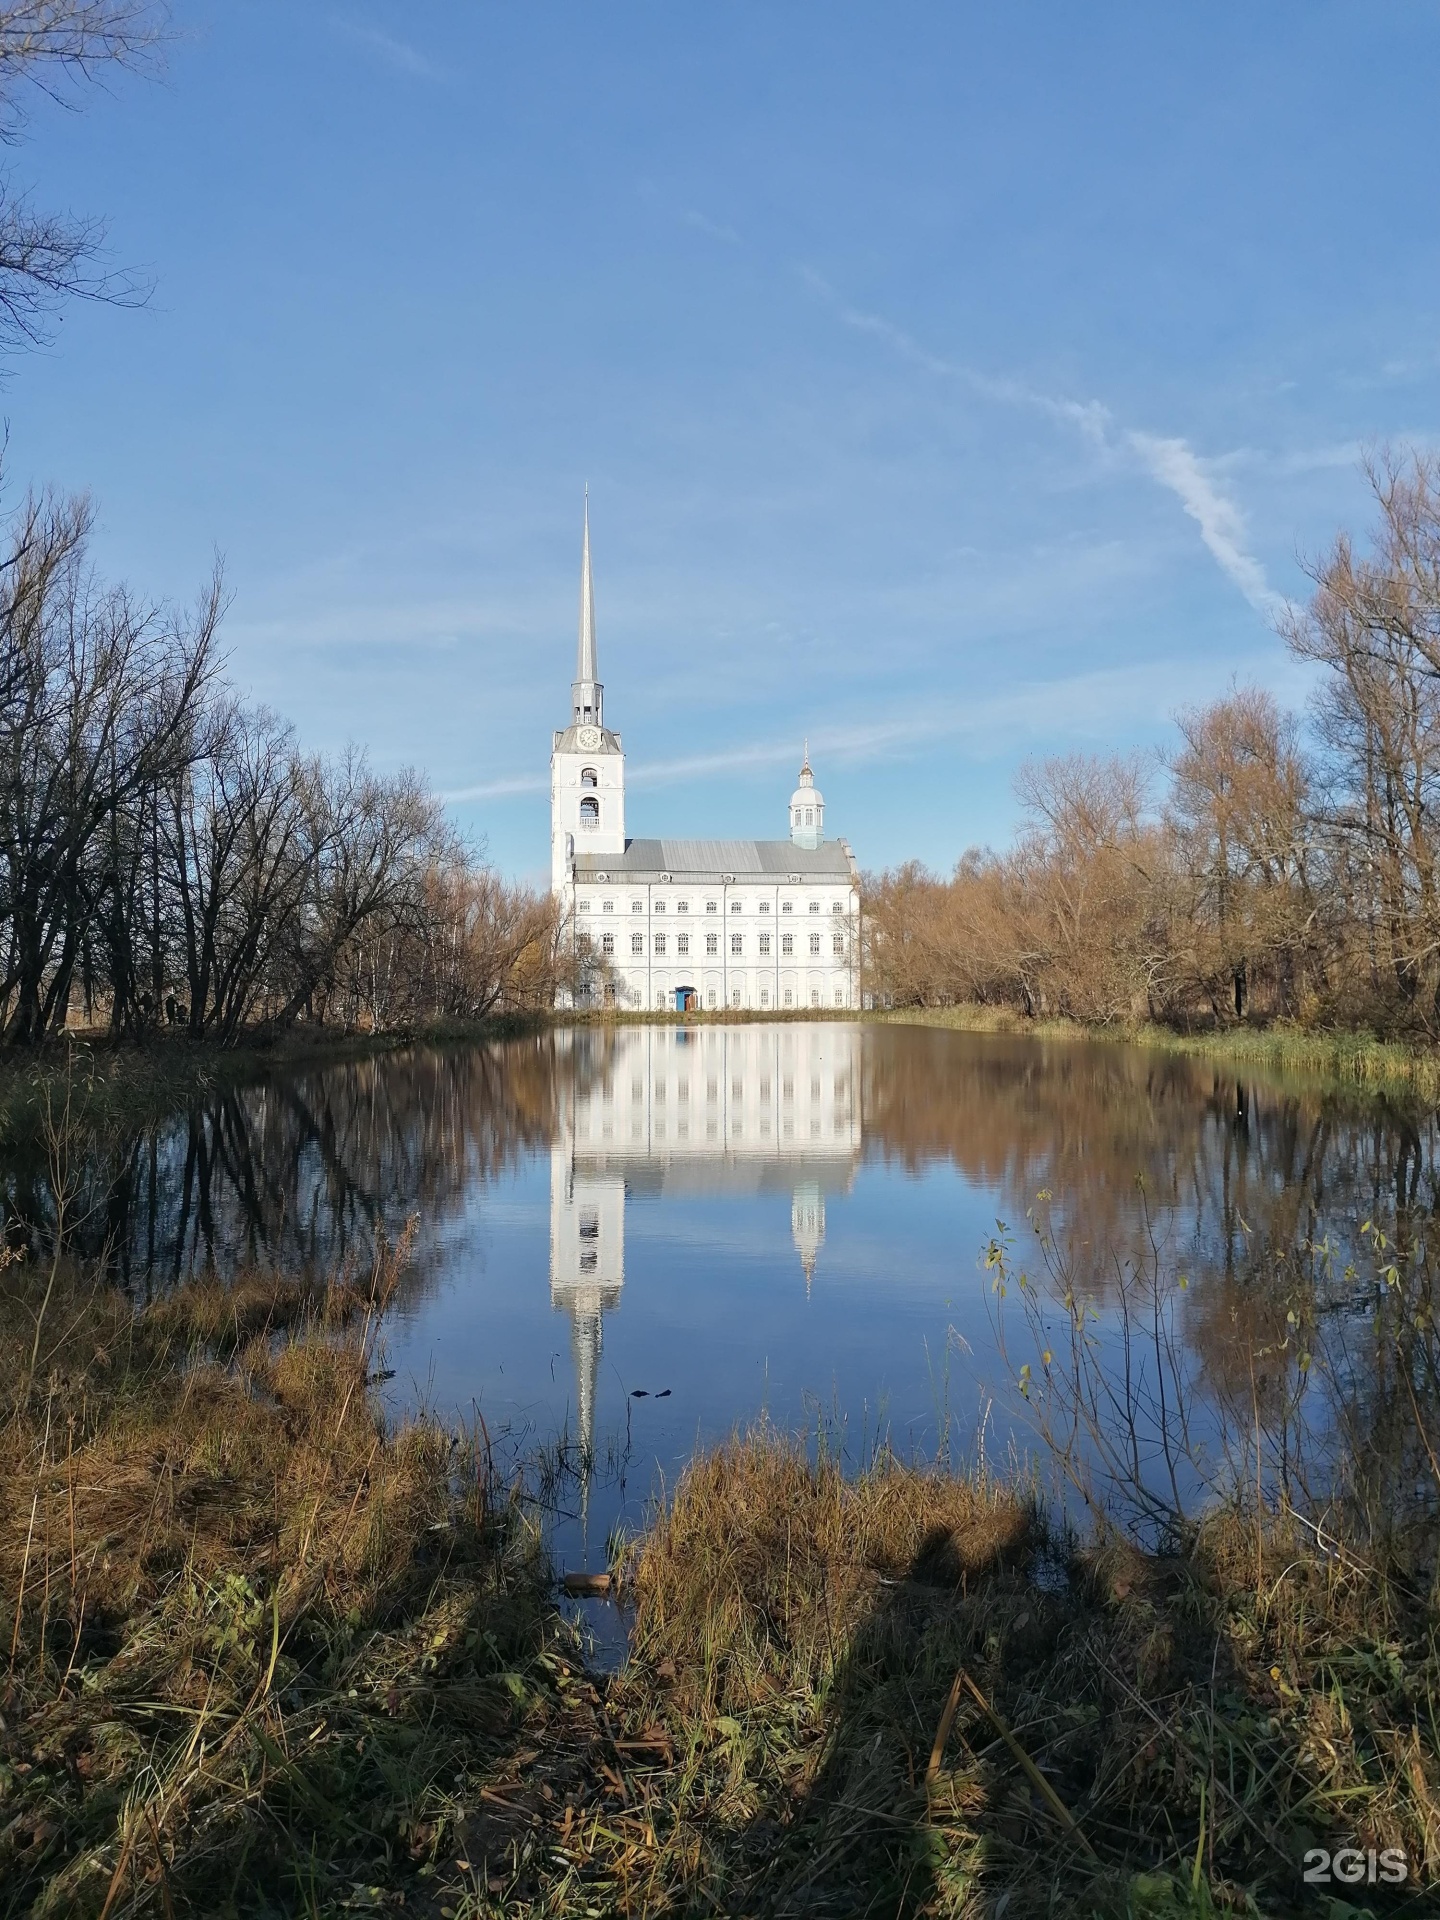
[814,267,1284,614]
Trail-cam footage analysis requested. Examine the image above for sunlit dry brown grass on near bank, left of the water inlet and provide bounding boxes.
[0,1261,568,1920]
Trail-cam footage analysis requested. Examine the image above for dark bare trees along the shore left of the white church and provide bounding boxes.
[0,497,572,1046]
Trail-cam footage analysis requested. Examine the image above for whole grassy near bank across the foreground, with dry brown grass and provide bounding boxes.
[0,1256,1440,1920]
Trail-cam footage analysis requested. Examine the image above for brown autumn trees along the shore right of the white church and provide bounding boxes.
[866,453,1440,1035]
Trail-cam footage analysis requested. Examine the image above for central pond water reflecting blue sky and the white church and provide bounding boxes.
[388,1025,1059,1559]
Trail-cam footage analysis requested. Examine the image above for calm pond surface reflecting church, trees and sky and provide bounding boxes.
[0,1023,1436,1565]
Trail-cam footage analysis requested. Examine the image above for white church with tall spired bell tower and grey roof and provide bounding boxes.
[549,505,860,1014]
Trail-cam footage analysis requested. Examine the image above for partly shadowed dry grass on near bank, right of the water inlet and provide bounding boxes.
[537,1434,1440,1920]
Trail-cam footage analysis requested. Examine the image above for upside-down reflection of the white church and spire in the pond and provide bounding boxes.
[549,1023,860,1452]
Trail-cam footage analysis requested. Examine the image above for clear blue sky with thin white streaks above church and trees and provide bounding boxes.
[0,0,1440,876]
